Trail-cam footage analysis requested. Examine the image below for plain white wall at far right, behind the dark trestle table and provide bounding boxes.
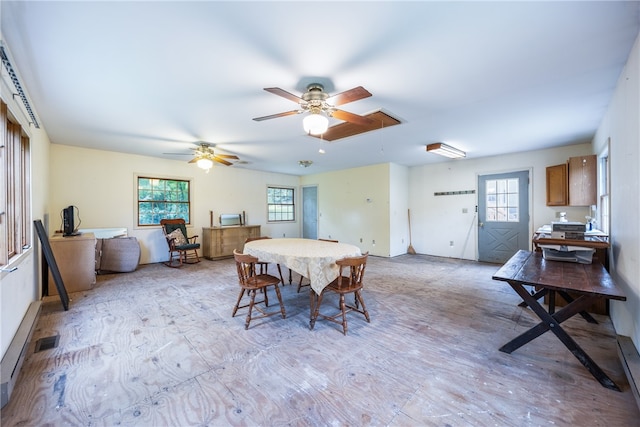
[594,31,640,349]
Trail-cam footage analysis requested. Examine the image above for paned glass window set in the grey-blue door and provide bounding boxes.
[486,178,520,222]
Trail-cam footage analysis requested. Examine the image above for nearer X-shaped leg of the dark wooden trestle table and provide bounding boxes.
[500,281,620,391]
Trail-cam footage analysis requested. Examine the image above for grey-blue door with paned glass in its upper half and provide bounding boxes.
[478,171,531,264]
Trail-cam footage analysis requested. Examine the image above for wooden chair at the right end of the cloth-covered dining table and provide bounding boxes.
[309,252,371,335]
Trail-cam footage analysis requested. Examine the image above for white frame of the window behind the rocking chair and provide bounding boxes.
[134,174,193,228]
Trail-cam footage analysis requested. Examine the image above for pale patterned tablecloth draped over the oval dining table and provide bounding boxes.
[244,238,361,294]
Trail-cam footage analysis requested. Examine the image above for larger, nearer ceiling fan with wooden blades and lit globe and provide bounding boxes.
[253,83,371,135]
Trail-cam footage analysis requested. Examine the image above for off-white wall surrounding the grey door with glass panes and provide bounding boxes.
[409,144,591,260]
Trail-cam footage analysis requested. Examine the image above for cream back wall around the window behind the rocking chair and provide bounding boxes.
[50,144,300,264]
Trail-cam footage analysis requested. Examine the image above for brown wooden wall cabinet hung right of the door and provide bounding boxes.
[547,154,597,206]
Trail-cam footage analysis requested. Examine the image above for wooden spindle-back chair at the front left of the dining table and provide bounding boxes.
[231,249,286,329]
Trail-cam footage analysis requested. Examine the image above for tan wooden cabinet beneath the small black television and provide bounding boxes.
[47,233,96,295]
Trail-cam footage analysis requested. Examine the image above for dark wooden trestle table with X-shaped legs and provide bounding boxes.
[493,250,626,391]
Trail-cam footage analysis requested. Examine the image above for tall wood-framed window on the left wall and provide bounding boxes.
[0,101,31,265]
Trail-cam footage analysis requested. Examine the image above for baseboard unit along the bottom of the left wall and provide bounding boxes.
[0,301,42,408]
